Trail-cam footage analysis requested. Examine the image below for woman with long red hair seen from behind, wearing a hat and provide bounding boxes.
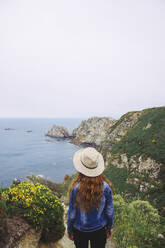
[67,147,113,248]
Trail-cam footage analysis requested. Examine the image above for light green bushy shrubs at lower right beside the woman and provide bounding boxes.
[113,195,162,248]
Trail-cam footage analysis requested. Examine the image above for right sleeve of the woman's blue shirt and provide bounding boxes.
[105,186,114,229]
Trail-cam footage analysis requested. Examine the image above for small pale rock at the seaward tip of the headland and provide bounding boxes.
[46,125,71,138]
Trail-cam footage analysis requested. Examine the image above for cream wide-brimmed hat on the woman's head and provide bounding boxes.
[73,147,104,177]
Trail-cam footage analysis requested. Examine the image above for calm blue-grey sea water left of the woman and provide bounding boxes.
[0,118,82,187]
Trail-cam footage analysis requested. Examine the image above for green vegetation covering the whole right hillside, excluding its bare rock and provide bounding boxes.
[101,107,165,248]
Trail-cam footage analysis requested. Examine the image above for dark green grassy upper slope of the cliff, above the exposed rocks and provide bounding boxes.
[111,107,165,167]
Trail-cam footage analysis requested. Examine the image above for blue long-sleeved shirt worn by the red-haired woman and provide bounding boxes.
[67,182,114,234]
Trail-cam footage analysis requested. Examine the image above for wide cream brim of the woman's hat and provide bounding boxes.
[73,148,104,177]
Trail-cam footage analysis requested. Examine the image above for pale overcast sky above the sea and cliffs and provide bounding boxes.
[0,0,165,118]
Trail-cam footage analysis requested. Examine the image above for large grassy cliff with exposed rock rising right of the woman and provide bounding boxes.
[100,107,165,215]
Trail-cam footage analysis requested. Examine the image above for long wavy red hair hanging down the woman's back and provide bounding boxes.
[69,173,113,212]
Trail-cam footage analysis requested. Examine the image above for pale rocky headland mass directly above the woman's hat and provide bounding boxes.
[71,117,116,146]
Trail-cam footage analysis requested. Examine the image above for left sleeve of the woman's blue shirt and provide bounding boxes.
[67,188,77,234]
